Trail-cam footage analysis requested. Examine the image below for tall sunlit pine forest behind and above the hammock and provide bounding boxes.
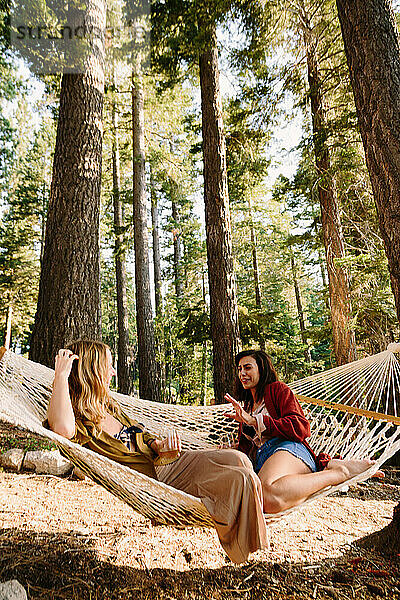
[0,0,400,405]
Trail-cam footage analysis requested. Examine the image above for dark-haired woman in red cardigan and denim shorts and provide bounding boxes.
[225,350,383,513]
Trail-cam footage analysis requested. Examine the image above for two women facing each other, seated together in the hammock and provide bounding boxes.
[47,340,380,563]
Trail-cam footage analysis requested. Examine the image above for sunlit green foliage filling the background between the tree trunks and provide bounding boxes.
[0,0,399,403]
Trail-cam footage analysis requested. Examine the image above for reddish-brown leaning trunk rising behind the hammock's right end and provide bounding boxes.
[304,23,356,365]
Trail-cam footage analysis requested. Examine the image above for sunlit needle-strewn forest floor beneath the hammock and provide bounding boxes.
[0,424,400,600]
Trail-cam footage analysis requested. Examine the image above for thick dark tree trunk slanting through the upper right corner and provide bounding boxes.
[337,0,400,319]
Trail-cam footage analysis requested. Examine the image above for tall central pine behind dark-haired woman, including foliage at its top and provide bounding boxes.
[153,2,240,402]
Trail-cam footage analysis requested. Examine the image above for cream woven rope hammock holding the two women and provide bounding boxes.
[0,344,400,527]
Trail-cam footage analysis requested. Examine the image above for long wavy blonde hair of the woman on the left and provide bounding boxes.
[67,340,120,431]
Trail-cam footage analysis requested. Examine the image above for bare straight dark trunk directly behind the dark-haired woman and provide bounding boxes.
[200,30,240,402]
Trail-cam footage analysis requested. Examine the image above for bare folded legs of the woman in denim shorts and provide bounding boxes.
[258,450,383,514]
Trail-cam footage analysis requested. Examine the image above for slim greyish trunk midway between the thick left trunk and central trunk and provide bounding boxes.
[132,70,160,401]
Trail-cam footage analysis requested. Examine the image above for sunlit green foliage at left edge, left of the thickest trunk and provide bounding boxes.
[0,58,55,350]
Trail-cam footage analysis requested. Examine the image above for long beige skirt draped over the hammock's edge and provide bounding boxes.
[156,449,267,563]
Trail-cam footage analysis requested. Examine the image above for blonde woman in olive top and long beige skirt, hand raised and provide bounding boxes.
[47,340,267,563]
